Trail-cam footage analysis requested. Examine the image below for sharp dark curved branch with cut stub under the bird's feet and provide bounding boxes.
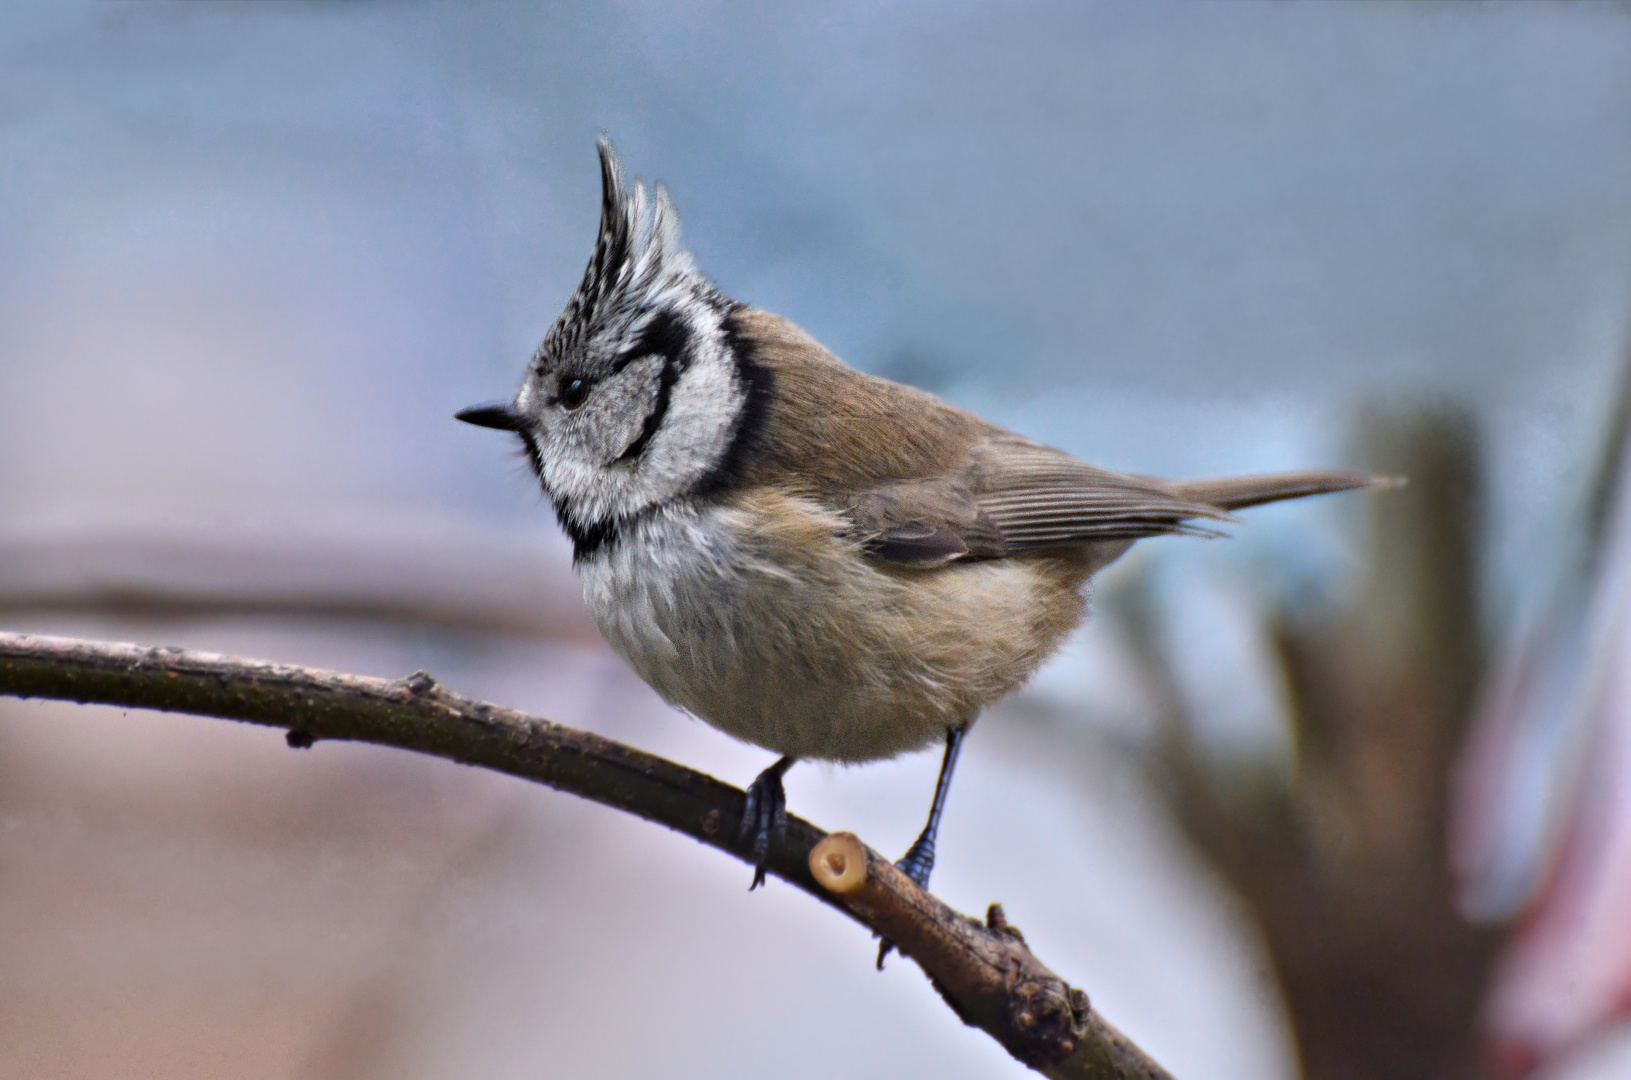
[0,633,1171,1080]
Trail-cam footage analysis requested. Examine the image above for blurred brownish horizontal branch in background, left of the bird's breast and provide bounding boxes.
[0,519,600,641]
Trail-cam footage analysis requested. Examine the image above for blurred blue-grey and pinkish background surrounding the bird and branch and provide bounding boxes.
[0,2,1631,1078]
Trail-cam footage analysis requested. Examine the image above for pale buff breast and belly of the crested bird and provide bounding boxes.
[581,489,1101,762]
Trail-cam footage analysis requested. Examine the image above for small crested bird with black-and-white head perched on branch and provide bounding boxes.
[455,134,1386,907]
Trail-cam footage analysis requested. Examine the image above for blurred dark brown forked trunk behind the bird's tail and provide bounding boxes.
[1135,406,1505,1080]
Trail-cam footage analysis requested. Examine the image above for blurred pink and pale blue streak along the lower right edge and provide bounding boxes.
[1463,447,1631,1075]
